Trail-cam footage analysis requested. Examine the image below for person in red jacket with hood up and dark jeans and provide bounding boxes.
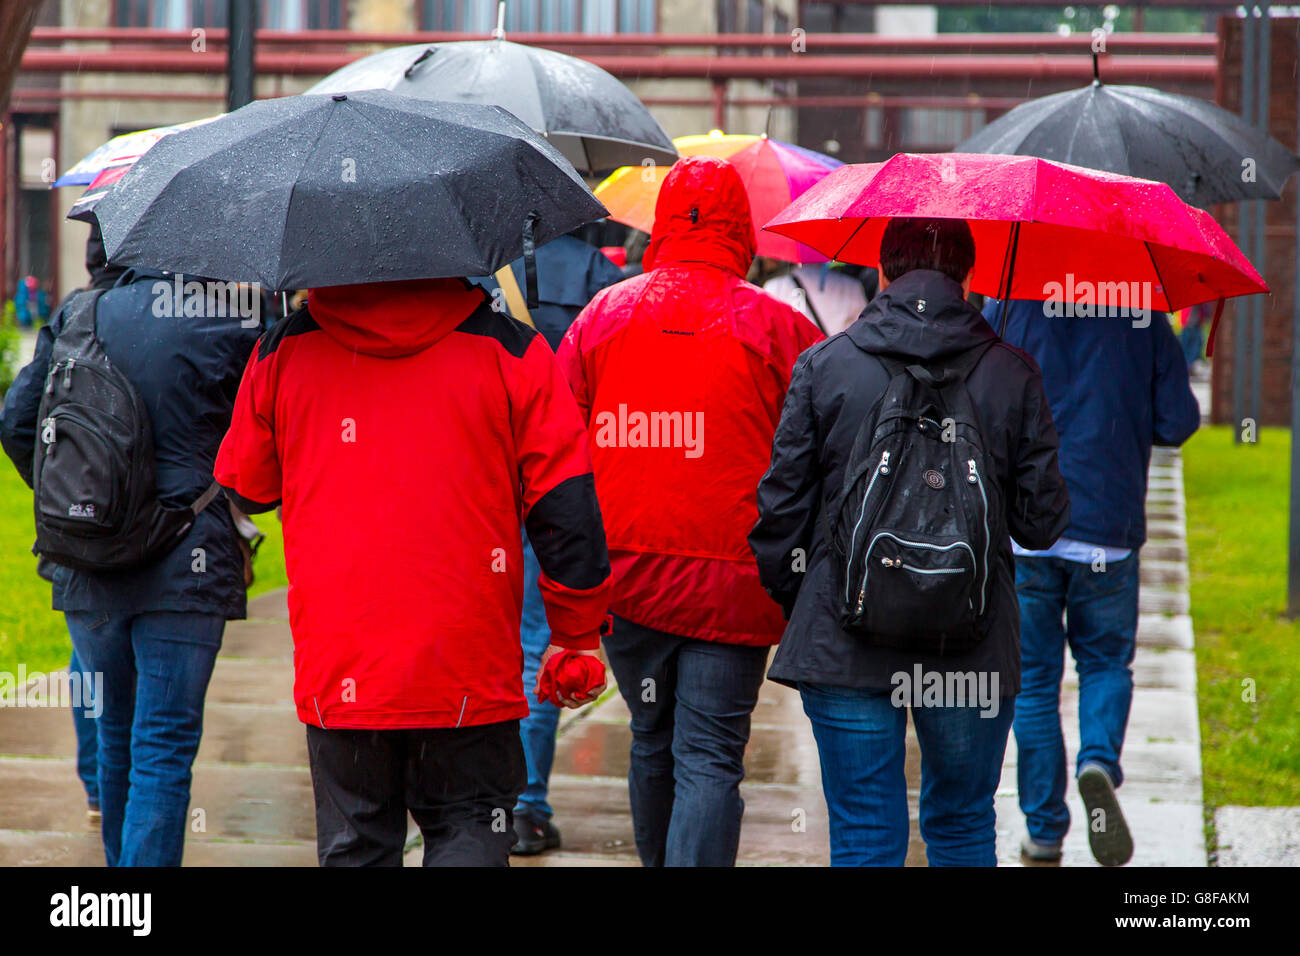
[558,156,822,866]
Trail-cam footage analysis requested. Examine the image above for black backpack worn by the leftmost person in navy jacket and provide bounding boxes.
[33,291,221,571]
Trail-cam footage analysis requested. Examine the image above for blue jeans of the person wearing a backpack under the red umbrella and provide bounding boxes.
[800,683,1015,866]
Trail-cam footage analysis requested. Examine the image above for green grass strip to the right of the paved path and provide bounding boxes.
[1183,427,1300,806]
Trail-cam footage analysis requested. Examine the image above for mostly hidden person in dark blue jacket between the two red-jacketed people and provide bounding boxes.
[471,234,623,856]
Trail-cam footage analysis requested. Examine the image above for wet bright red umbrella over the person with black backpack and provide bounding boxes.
[766,152,1269,345]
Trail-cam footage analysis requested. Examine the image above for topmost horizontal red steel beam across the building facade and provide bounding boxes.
[25,27,1216,56]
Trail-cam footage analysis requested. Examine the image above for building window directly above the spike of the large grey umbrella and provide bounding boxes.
[416,0,658,34]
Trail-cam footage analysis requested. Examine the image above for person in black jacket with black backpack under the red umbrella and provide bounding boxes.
[749,219,1070,866]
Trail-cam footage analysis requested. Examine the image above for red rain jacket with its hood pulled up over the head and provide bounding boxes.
[558,156,822,645]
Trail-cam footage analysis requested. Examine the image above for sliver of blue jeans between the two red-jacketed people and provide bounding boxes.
[515,535,560,819]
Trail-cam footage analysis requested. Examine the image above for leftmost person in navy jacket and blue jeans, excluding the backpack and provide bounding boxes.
[0,260,260,866]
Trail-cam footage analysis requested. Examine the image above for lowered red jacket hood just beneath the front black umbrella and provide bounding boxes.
[307,278,486,359]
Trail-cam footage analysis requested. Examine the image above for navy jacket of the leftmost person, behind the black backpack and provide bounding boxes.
[0,269,260,620]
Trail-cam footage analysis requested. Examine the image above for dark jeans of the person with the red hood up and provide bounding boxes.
[605,618,768,866]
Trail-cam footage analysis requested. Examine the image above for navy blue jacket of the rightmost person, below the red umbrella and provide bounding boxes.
[984,300,1201,548]
